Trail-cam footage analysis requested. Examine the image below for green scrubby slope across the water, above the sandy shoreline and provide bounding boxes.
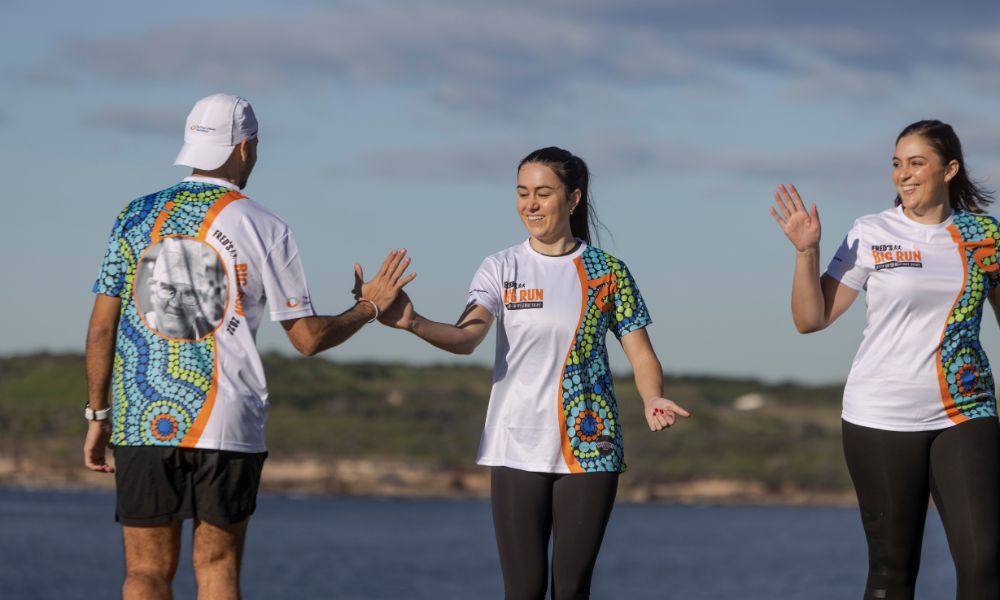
[0,355,849,490]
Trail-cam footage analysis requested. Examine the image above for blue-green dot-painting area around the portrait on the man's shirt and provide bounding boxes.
[94,182,230,446]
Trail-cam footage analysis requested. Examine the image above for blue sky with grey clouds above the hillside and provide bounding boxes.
[0,0,1000,382]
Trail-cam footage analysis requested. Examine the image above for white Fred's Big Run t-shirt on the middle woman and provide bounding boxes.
[469,241,651,473]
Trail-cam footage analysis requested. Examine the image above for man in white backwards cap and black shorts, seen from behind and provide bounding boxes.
[84,94,415,600]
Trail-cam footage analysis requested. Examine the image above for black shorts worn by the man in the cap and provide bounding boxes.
[114,446,267,527]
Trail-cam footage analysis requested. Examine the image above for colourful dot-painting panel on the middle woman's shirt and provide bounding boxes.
[562,246,650,472]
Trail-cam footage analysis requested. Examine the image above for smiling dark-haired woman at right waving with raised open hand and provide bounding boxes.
[771,121,1000,600]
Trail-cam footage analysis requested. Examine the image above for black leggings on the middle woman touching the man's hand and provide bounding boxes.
[490,467,618,600]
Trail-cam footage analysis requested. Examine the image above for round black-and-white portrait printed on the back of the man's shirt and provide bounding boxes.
[133,235,229,342]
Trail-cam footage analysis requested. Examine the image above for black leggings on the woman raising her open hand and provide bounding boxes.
[843,418,1000,600]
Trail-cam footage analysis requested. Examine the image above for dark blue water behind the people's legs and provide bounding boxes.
[0,489,955,600]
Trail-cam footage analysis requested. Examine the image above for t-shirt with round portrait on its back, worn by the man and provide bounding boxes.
[93,177,315,452]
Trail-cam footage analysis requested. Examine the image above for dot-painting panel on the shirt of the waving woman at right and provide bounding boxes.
[938,212,1000,418]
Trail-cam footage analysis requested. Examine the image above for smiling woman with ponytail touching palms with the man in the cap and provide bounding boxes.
[379,147,688,600]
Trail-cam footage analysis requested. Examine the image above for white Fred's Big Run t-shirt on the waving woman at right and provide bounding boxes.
[827,207,1000,431]
